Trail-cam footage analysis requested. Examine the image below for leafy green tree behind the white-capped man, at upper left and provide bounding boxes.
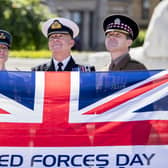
[0,0,54,50]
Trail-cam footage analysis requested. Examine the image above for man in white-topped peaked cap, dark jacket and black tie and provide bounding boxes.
[32,17,95,72]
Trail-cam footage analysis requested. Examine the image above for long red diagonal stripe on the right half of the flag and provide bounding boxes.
[83,75,168,115]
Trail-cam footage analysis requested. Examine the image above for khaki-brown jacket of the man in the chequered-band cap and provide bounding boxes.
[109,54,146,71]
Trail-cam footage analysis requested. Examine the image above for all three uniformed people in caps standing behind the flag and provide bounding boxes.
[0,15,146,72]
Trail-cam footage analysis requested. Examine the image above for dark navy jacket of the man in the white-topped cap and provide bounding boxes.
[31,57,95,72]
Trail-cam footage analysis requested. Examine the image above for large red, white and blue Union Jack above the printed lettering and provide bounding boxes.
[0,70,168,147]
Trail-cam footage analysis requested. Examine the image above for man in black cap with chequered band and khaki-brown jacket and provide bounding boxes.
[103,15,146,71]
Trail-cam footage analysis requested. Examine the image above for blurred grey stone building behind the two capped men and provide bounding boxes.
[42,0,160,50]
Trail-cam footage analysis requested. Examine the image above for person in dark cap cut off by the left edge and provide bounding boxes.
[0,29,12,71]
